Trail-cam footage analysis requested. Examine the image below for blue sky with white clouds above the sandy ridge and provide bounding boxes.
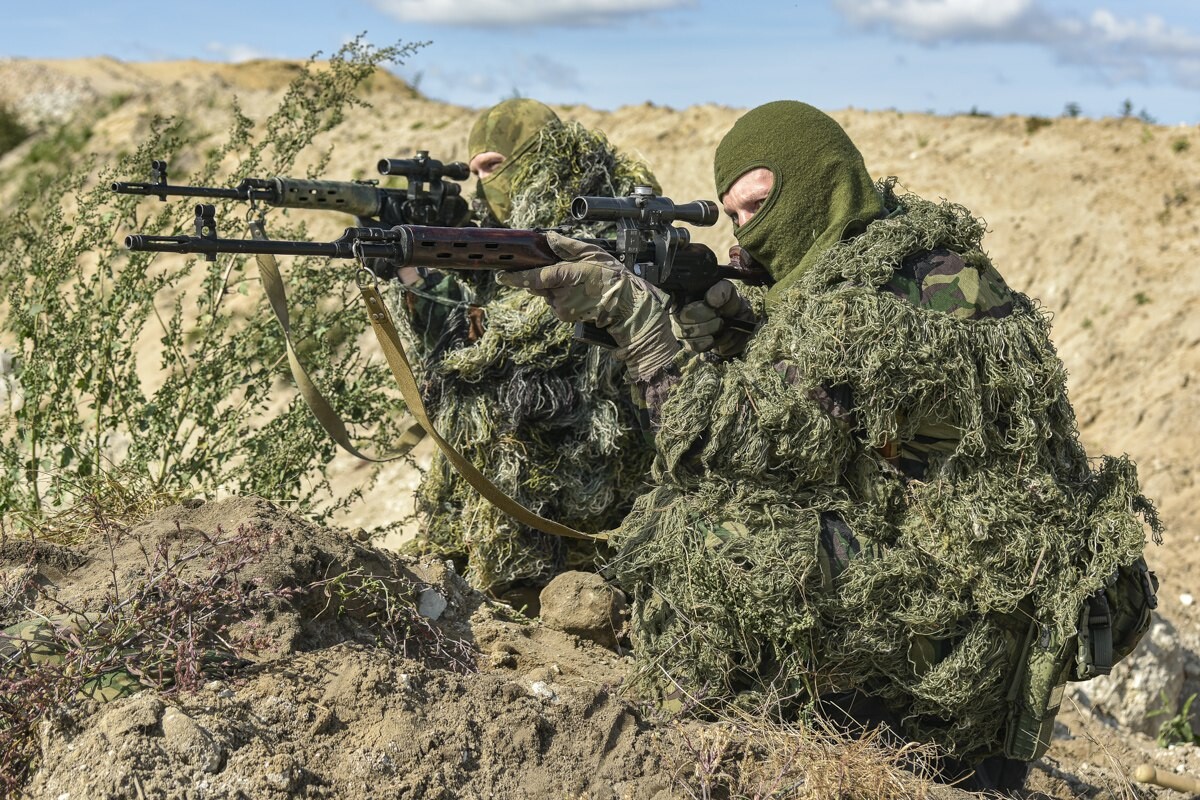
[7,0,1200,125]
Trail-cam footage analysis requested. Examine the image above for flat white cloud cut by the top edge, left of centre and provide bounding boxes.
[372,0,696,26]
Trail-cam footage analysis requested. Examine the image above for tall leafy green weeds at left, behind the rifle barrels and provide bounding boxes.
[0,40,415,524]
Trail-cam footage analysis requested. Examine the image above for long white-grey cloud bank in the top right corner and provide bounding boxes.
[834,0,1200,88]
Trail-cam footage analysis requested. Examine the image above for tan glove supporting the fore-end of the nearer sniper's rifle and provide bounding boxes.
[496,231,679,380]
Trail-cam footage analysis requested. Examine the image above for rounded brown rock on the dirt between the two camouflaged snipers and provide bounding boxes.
[541,572,628,649]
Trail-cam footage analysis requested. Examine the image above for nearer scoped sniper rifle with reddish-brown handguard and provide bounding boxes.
[125,186,769,347]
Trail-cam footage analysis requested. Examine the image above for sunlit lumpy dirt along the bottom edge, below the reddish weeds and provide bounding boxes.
[30,644,670,798]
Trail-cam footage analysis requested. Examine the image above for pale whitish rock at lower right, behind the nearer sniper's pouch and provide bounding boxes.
[1070,615,1184,736]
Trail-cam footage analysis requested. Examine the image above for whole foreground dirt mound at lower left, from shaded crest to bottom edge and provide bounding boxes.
[7,499,686,798]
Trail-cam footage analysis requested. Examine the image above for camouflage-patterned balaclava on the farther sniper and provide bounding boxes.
[467,97,558,224]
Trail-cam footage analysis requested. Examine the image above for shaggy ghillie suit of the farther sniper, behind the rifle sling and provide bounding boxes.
[391,101,656,590]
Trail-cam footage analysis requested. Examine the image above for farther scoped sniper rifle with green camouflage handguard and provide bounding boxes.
[112,150,470,228]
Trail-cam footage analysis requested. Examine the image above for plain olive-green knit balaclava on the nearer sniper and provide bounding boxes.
[713,100,883,305]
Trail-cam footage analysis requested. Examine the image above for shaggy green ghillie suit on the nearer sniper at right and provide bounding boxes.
[612,185,1159,757]
